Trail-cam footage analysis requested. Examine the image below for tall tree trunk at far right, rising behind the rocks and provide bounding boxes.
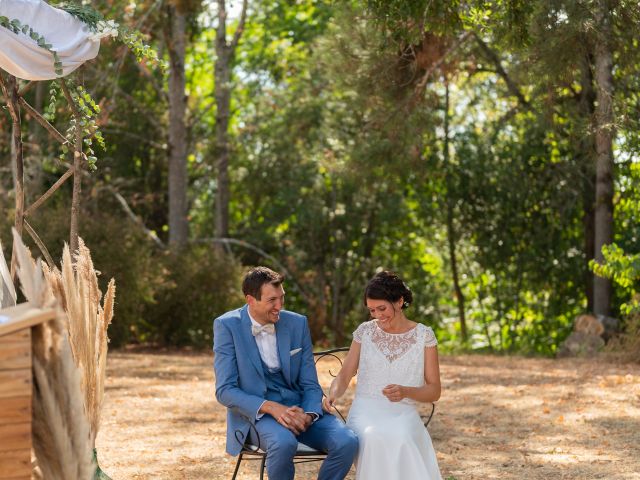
[593,0,614,315]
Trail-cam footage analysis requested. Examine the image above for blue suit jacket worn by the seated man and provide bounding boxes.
[213,305,323,455]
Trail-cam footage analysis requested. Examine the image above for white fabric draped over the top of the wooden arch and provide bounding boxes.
[0,0,100,80]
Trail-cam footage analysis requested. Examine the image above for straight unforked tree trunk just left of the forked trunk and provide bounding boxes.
[168,5,189,248]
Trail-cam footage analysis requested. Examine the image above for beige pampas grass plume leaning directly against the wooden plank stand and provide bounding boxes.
[14,230,96,480]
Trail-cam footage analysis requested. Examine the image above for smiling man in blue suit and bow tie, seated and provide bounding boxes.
[213,267,358,480]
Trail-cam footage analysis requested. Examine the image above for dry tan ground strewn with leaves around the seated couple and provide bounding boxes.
[97,352,640,480]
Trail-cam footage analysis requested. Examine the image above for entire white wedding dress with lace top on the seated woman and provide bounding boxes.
[347,320,442,480]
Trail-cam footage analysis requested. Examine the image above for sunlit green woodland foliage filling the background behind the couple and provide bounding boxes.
[5,0,640,355]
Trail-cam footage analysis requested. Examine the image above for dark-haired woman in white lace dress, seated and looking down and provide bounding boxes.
[323,271,442,480]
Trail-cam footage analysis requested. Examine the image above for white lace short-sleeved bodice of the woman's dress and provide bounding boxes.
[353,320,438,403]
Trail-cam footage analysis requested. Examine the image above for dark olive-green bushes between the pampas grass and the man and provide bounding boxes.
[0,193,244,348]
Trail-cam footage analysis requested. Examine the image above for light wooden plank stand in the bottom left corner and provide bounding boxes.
[0,303,55,480]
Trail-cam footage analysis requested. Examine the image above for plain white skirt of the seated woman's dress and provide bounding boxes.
[347,396,442,480]
